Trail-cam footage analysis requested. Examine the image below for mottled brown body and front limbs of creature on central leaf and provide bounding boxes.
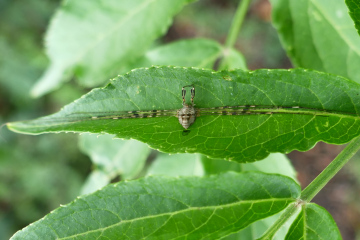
[176,85,197,129]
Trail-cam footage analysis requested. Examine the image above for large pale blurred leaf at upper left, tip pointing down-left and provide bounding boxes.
[32,0,192,96]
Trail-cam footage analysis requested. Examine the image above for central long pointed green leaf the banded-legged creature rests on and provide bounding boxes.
[7,67,360,162]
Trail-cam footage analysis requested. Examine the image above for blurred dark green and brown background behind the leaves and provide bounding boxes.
[0,0,360,239]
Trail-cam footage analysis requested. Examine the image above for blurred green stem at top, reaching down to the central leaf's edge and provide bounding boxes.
[218,0,251,70]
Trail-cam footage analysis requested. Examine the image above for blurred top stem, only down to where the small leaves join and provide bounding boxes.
[225,0,250,49]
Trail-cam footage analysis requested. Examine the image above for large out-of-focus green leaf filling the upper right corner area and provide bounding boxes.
[271,0,360,82]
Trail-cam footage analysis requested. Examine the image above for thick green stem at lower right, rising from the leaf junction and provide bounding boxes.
[300,137,360,202]
